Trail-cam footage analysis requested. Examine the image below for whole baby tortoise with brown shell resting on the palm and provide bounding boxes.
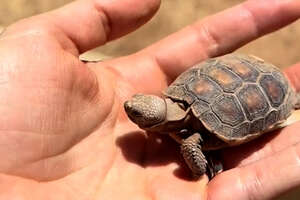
[124,54,300,178]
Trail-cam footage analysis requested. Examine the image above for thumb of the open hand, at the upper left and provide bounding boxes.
[3,0,160,53]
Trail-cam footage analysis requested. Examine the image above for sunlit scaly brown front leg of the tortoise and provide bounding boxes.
[181,133,208,178]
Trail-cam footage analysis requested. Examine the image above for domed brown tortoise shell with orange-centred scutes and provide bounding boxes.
[165,54,293,144]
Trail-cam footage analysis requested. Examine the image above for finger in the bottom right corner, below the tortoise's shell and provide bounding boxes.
[208,141,300,200]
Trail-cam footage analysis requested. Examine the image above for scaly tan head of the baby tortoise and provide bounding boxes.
[124,94,167,128]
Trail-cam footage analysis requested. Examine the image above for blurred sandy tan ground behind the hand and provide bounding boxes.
[0,0,300,200]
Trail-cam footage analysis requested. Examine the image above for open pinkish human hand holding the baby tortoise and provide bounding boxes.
[0,0,300,200]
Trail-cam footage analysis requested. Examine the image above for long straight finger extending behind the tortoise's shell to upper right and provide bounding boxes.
[141,0,300,78]
